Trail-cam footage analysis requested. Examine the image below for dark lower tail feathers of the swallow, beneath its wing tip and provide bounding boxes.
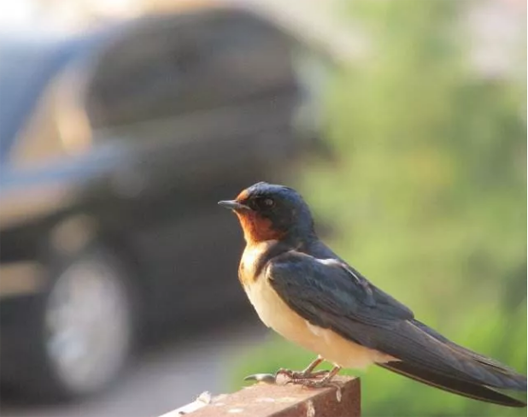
[377,362,526,407]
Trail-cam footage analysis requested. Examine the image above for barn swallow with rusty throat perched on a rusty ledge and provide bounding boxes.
[218,182,526,407]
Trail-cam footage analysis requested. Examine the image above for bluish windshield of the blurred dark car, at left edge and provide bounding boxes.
[0,40,74,161]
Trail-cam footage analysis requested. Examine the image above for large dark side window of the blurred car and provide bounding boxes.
[86,11,292,134]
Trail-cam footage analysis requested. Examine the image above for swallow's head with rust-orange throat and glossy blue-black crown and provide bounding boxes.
[218,182,315,244]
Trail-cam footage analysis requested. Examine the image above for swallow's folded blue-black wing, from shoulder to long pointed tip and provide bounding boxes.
[265,251,526,400]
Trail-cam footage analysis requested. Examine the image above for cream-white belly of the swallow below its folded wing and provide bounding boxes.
[244,268,395,368]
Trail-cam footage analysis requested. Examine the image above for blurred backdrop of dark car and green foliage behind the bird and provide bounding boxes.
[0,0,527,417]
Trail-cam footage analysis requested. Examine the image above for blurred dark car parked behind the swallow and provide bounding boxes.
[0,9,322,399]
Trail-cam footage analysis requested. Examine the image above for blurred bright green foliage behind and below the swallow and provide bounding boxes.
[230,0,527,417]
